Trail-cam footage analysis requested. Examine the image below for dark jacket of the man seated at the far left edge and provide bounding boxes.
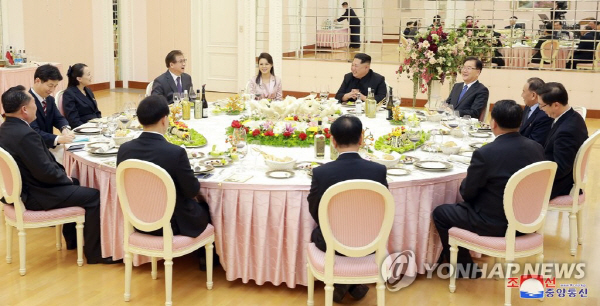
[0,117,79,210]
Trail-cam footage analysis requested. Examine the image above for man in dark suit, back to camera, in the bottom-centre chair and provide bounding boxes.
[307,116,388,302]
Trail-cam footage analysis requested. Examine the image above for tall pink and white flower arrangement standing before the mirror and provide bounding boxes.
[396,27,467,107]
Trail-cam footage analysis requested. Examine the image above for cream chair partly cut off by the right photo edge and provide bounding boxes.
[548,130,600,256]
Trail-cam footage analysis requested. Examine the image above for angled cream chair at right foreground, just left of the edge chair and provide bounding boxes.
[448,161,557,306]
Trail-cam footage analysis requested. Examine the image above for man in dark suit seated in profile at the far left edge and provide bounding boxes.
[0,85,114,264]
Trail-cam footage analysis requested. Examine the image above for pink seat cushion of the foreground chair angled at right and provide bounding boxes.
[448,227,544,252]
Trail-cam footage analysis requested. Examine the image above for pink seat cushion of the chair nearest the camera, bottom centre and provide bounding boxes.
[308,243,379,277]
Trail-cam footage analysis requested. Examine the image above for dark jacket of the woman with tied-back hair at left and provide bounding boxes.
[63,86,102,128]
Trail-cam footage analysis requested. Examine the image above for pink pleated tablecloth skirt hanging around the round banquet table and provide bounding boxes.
[64,151,466,288]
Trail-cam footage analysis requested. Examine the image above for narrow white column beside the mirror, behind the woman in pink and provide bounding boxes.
[269,0,283,76]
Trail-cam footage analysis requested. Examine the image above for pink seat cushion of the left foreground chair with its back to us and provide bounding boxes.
[129,224,215,251]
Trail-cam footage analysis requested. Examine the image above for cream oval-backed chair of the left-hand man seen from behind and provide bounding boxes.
[117,159,215,306]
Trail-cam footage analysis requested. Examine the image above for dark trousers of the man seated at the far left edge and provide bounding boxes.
[27,178,102,262]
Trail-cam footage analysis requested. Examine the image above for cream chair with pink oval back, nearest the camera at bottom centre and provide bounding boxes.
[307,180,396,306]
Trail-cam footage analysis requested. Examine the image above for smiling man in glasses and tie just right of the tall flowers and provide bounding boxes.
[446,57,490,119]
